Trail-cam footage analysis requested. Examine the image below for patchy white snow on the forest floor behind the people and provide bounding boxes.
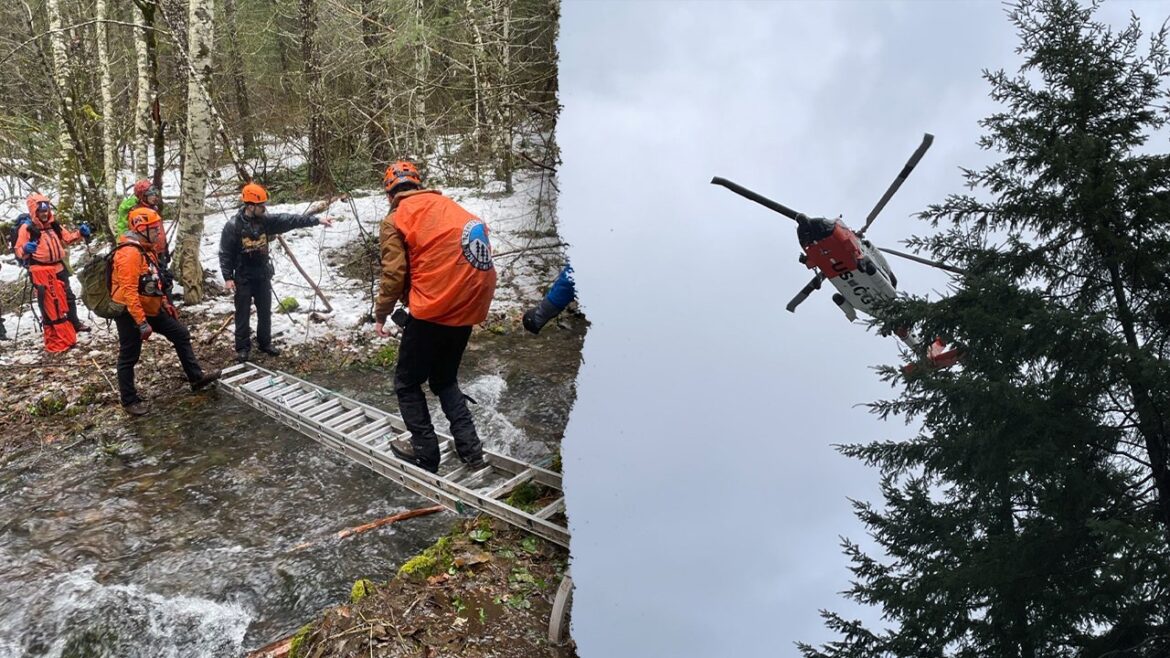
[0,160,564,365]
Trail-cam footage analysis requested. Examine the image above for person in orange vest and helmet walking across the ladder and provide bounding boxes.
[374,160,496,473]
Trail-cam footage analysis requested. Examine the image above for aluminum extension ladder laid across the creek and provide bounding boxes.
[219,363,569,548]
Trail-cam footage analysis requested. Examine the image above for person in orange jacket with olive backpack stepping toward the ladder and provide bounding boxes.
[110,206,220,416]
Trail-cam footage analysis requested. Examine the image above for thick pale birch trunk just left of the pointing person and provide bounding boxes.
[174,0,215,303]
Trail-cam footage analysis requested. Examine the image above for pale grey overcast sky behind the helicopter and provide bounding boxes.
[558,0,1170,658]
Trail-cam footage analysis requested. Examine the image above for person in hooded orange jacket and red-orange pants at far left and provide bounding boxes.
[16,193,89,352]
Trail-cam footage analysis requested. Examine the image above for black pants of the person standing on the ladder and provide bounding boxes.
[394,318,483,471]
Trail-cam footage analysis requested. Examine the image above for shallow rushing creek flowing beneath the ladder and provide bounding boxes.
[0,318,585,658]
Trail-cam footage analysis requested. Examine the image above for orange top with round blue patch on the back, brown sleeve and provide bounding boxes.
[374,190,496,327]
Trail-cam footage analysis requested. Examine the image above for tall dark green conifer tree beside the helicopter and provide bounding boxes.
[799,0,1170,658]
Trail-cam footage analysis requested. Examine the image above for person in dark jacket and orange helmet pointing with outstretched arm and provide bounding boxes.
[219,183,333,363]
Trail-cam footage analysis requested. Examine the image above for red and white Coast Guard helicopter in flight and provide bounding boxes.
[711,132,963,368]
